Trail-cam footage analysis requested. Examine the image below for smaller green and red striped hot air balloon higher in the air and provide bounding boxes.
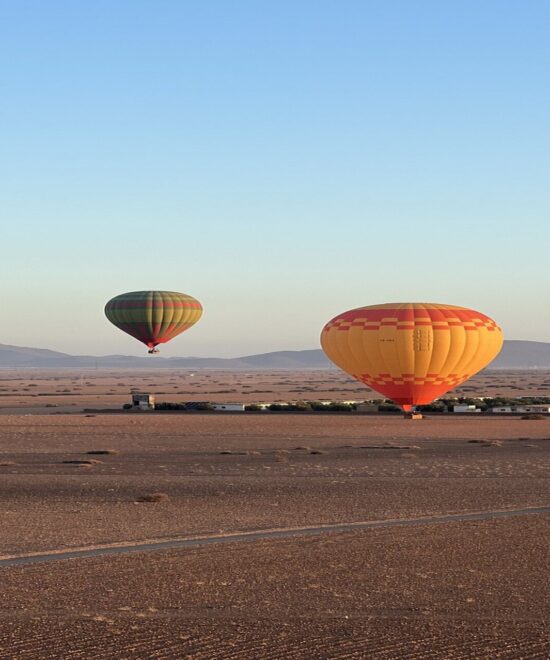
[105,291,202,353]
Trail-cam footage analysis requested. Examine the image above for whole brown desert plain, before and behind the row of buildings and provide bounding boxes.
[0,370,550,659]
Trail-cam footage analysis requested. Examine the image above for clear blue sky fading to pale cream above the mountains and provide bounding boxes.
[0,0,550,356]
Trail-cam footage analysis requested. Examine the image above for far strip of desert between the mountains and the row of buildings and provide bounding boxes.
[0,369,550,413]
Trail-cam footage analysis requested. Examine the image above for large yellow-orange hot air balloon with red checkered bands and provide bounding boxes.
[321,303,503,411]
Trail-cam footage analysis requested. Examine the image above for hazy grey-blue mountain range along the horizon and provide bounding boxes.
[0,340,550,370]
